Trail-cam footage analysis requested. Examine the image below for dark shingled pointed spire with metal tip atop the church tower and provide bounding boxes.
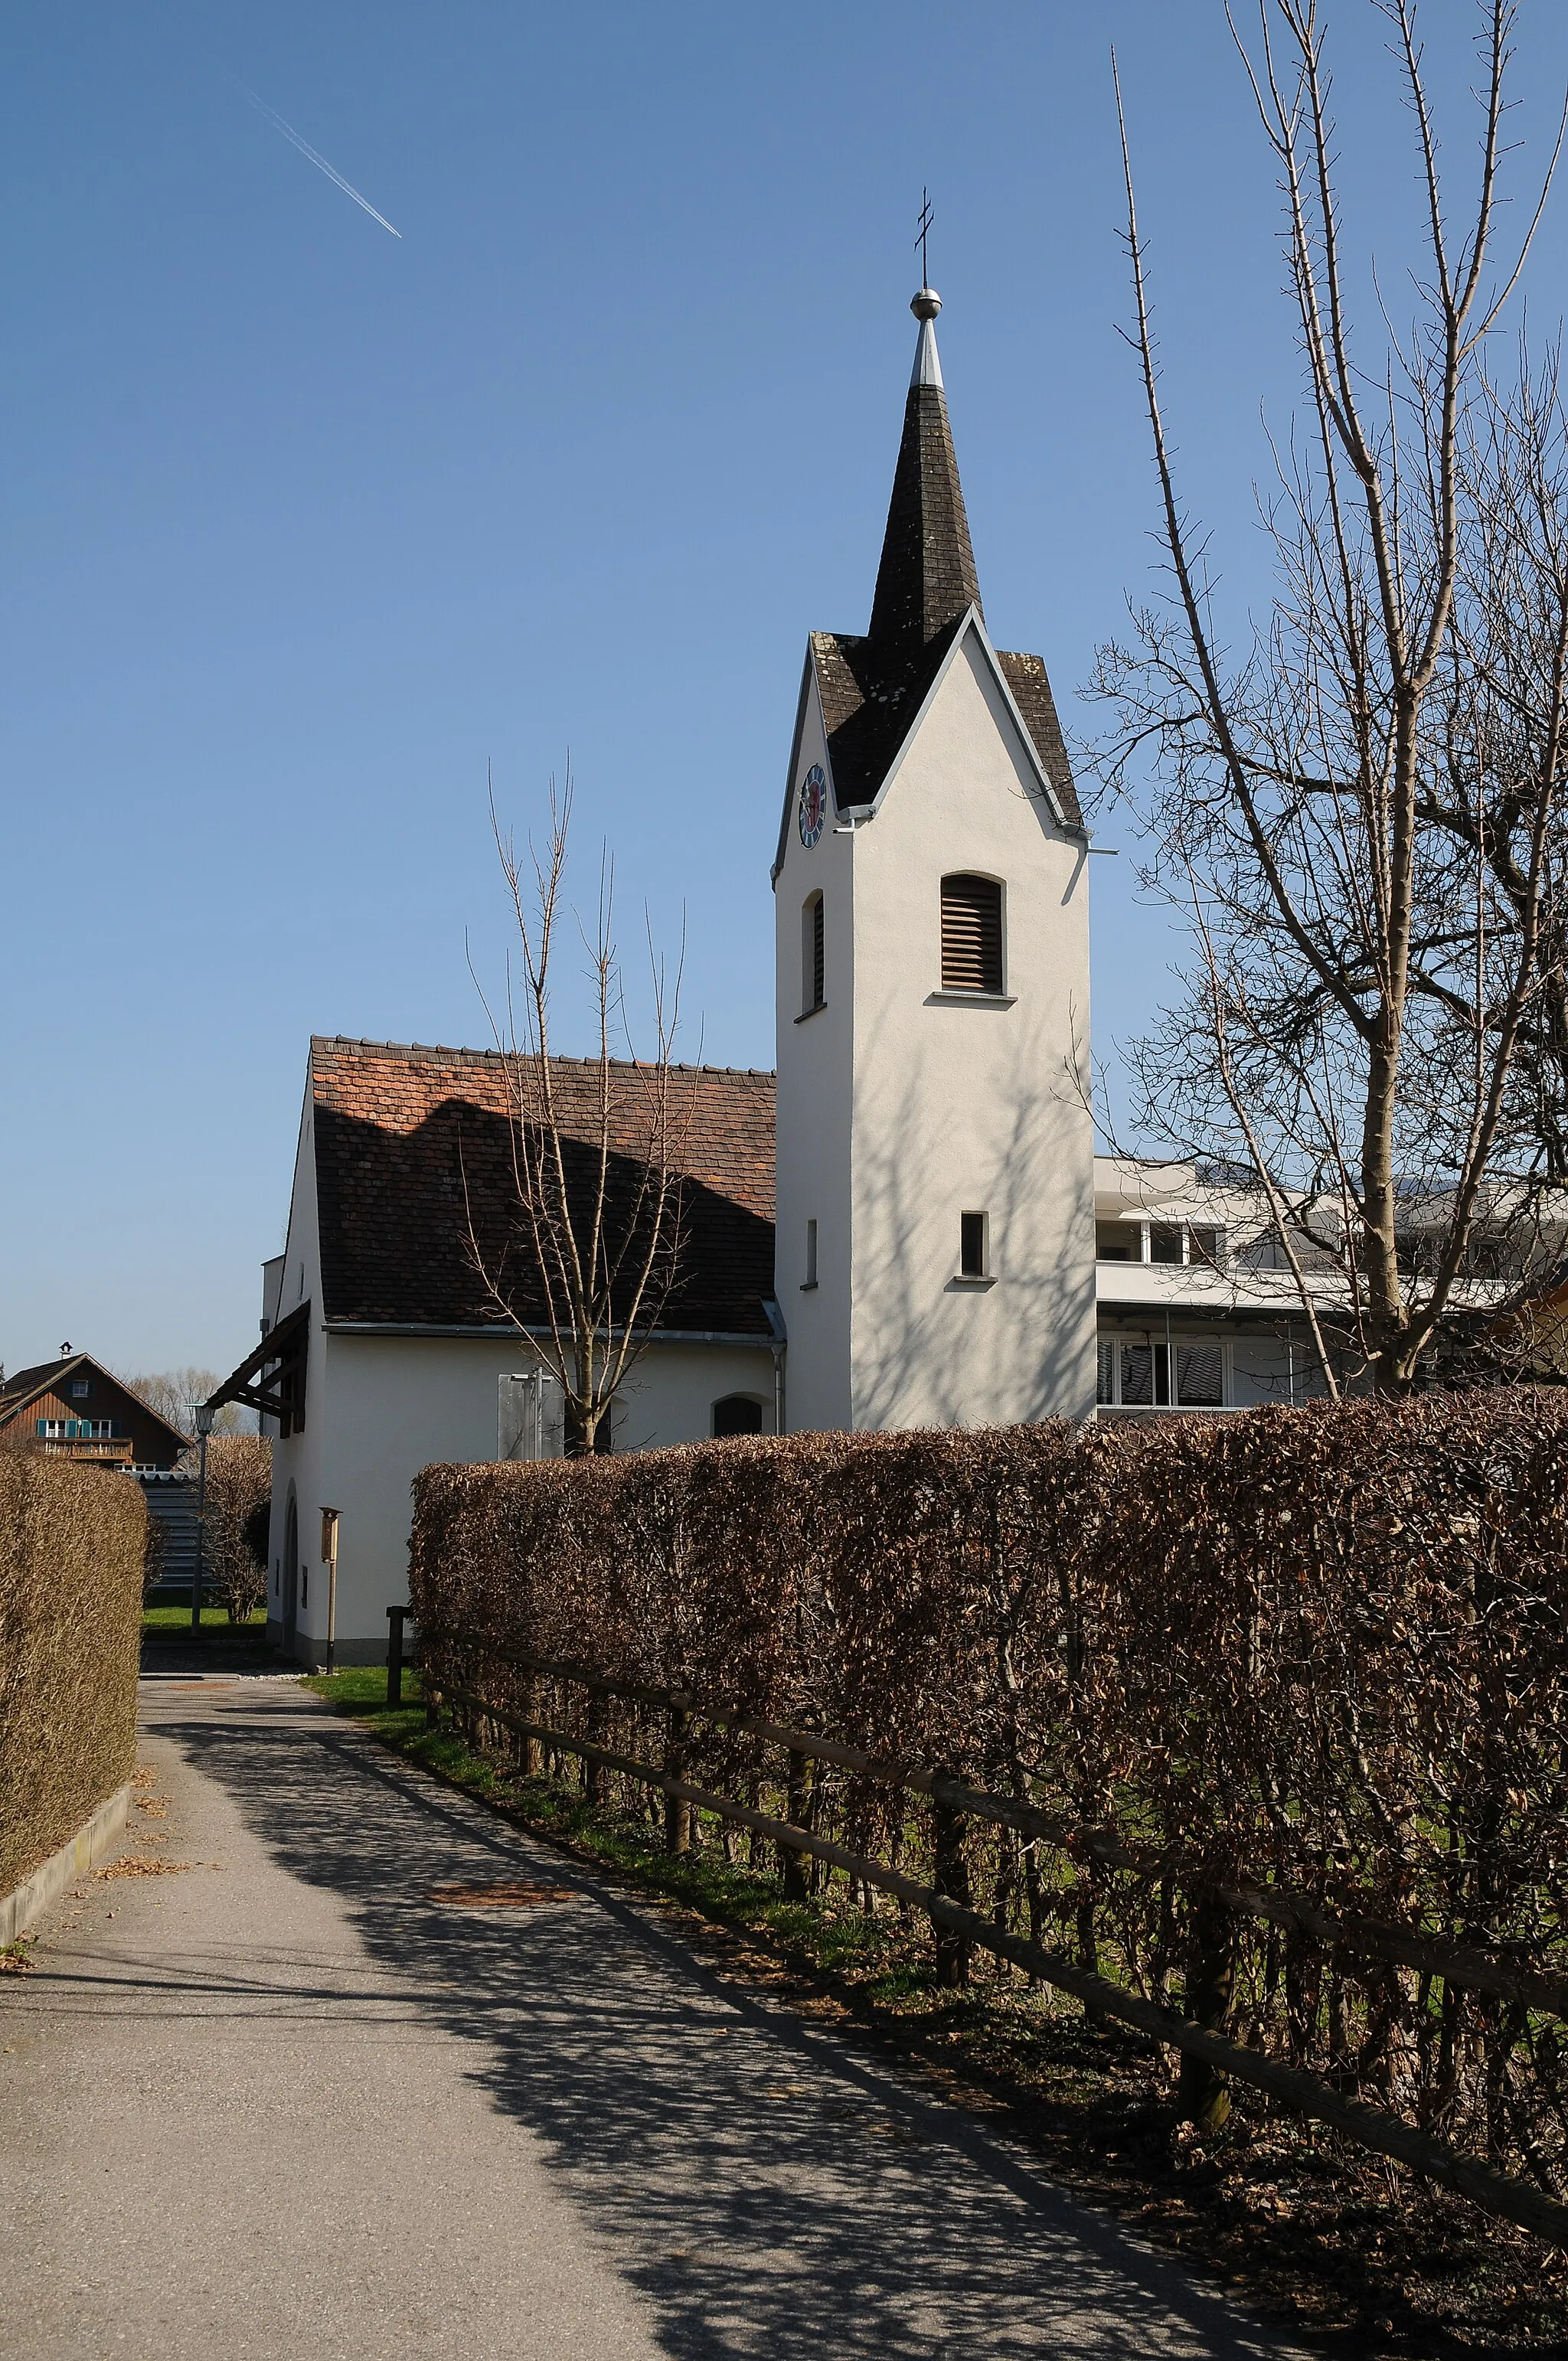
[867,288,980,661]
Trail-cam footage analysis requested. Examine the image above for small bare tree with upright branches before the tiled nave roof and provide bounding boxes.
[466,775,684,1455]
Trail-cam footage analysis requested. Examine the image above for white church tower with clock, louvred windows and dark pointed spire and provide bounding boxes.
[773,288,1096,1431]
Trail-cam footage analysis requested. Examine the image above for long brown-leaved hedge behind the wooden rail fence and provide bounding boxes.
[411,1388,1568,2193]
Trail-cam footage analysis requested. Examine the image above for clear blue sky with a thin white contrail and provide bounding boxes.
[0,0,1568,1367]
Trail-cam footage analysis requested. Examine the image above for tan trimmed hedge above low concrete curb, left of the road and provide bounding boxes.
[0,1452,146,1893]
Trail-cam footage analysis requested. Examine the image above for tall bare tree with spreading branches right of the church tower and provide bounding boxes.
[1091,0,1568,1390]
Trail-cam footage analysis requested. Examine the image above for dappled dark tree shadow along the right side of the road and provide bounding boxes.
[156,1690,1280,2361]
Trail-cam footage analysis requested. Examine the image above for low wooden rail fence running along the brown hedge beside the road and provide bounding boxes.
[420,1629,1568,2248]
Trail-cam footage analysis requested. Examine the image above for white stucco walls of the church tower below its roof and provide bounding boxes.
[777,630,1093,1429]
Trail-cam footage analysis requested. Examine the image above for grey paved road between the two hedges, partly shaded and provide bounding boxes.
[0,1677,1285,2361]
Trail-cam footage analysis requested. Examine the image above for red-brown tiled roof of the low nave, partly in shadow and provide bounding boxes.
[312,1037,775,1339]
